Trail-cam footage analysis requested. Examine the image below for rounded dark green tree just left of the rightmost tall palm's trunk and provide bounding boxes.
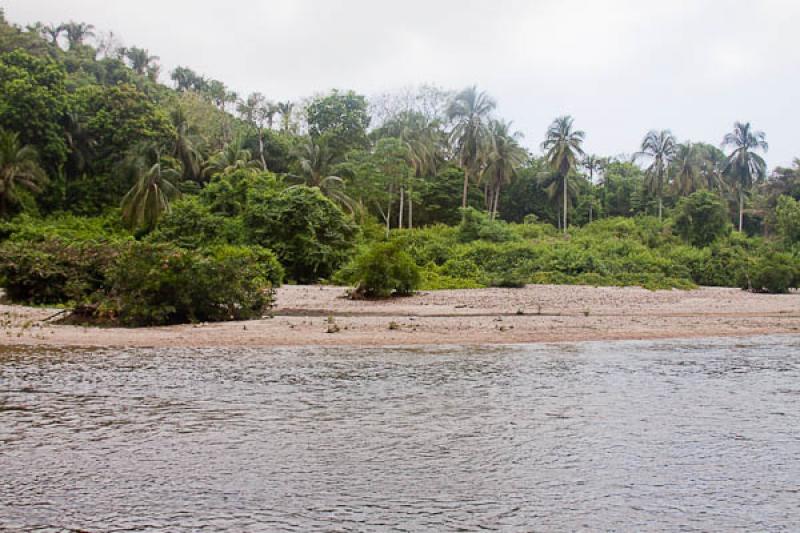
[675,191,731,246]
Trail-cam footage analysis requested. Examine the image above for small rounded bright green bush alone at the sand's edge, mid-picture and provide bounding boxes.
[346,242,421,298]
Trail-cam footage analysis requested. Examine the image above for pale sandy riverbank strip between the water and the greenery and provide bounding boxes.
[0,285,800,347]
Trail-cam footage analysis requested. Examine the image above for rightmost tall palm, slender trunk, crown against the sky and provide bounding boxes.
[722,122,769,232]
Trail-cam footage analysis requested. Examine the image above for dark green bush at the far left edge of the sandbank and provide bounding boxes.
[0,237,119,305]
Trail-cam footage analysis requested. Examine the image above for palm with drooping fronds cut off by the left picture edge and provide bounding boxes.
[0,129,47,216]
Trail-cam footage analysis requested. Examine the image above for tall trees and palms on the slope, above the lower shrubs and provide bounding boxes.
[0,9,800,233]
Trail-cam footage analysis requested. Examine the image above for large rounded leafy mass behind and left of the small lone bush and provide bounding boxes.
[244,186,357,283]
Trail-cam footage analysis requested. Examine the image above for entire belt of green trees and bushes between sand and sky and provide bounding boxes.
[0,12,800,325]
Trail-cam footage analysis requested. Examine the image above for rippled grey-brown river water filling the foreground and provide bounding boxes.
[0,336,800,531]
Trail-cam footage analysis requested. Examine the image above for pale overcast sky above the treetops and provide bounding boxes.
[6,0,800,166]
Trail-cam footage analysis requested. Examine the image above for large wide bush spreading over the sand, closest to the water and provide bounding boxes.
[104,243,282,326]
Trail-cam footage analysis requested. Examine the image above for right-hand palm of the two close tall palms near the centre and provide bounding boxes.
[483,120,528,220]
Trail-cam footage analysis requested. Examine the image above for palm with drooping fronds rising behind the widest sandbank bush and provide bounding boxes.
[122,152,181,230]
